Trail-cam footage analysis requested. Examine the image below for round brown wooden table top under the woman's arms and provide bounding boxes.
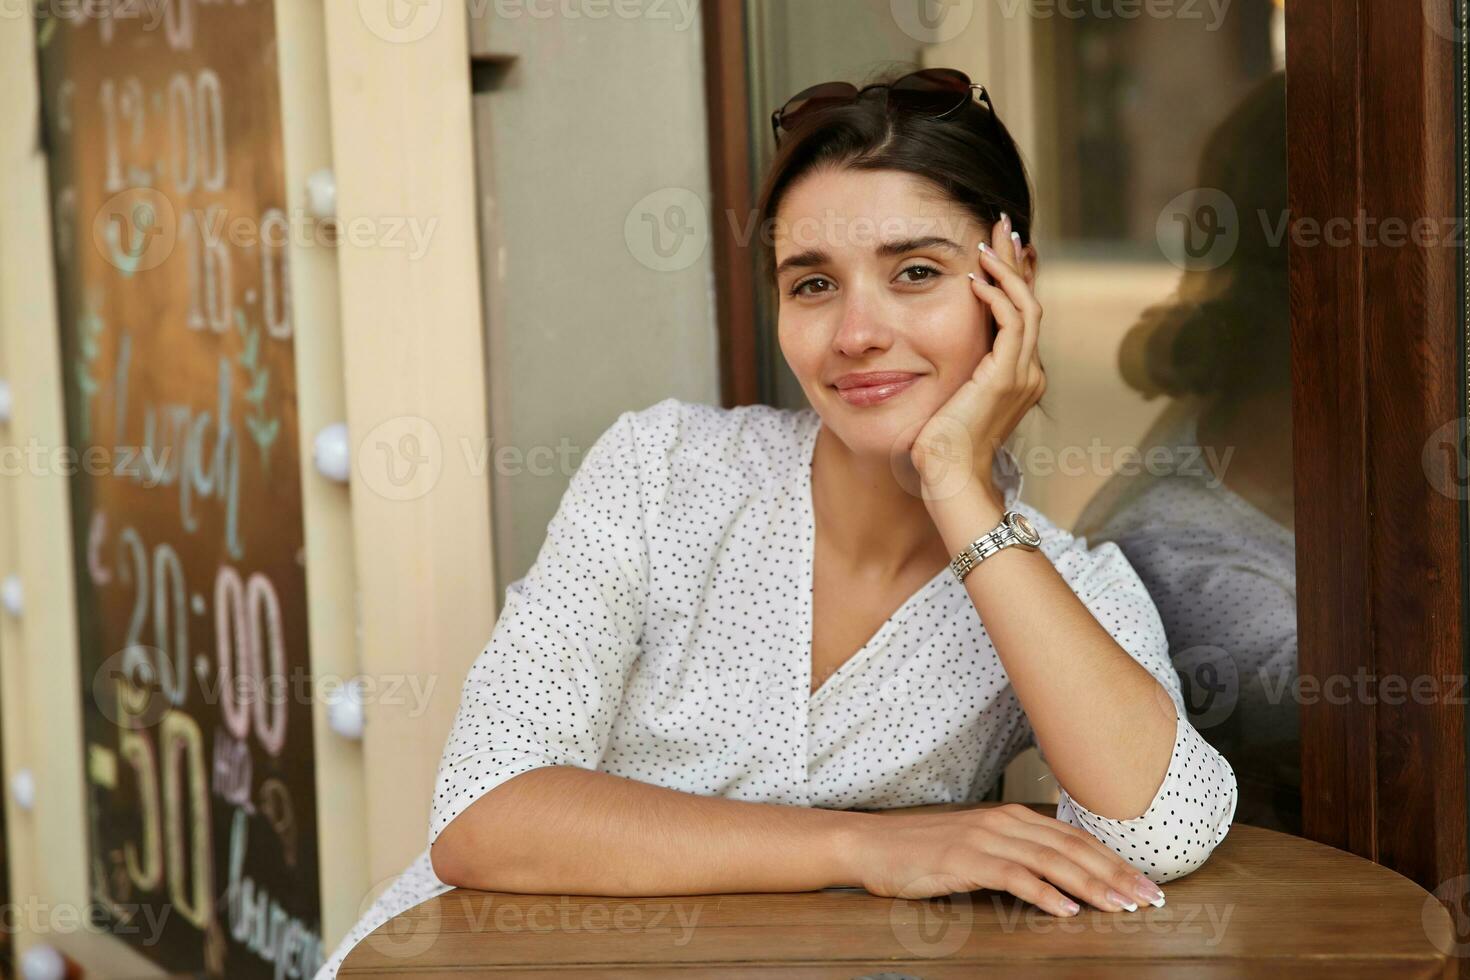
[338,807,1452,980]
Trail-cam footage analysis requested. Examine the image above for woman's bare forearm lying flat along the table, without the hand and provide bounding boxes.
[429,765,881,895]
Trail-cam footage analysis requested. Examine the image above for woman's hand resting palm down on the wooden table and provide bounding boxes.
[847,804,1163,915]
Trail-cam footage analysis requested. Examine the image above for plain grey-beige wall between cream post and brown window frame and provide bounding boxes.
[470,3,720,581]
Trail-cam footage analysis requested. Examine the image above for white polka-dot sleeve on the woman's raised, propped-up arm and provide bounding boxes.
[1026,538,1236,882]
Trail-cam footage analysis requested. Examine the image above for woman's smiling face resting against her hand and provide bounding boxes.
[772,169,1029,460]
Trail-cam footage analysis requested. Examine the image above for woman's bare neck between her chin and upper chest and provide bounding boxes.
[811,426,948,577]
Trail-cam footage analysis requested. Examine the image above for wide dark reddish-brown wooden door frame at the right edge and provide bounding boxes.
[1286,0,1467,889]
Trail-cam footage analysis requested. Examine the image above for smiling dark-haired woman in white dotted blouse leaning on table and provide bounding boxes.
[320,69,1236,976]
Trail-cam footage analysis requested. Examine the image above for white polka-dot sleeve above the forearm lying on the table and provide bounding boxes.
[429,411,648,845]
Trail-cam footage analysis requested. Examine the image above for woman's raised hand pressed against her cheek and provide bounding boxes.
[908,219,1047,500]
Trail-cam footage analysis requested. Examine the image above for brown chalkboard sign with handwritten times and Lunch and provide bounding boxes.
[37,0,321,977]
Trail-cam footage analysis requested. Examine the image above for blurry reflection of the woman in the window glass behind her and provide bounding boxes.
[1075,72,1301,832]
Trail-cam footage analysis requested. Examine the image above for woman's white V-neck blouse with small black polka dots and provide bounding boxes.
[322,398,1235,976]
